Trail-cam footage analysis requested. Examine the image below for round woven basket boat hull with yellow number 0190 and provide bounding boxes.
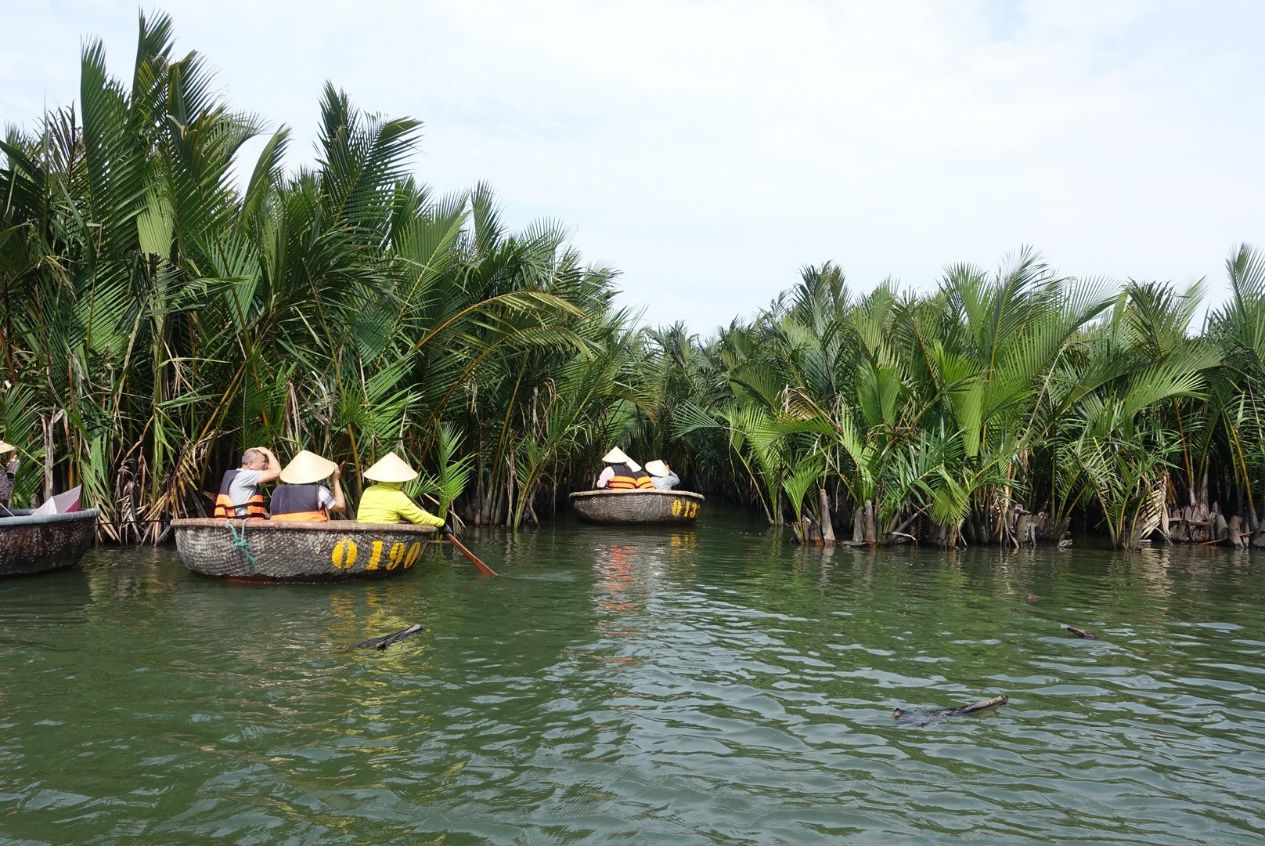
[171,518,435,582]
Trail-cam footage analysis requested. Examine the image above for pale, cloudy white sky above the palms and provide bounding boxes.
[0,0,1265,335]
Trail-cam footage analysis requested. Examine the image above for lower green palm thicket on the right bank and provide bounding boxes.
[659,248,1265,545]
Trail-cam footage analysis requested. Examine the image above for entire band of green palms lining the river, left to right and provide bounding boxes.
[0,15,1265,548]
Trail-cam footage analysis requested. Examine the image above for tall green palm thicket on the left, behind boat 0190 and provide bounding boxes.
[0,15,636,539]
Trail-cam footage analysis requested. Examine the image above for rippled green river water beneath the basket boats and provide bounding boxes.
[0,508,1265,845]
